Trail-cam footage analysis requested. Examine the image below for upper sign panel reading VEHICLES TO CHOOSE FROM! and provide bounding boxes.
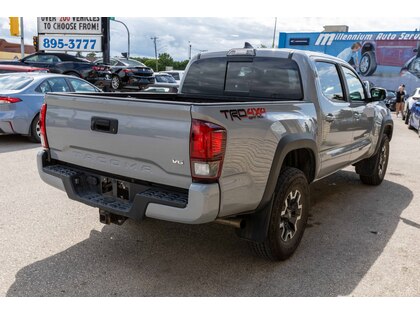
[38,17,102,35]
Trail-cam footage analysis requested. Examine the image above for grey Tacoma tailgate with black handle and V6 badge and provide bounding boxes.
[45,94,192,188]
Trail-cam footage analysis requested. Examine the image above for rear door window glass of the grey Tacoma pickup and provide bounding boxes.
[316,62,344,102]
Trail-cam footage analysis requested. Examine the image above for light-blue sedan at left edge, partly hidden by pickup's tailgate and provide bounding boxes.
[0,72,101,142]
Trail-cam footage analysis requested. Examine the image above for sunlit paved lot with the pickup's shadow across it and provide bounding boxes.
[0,116,420,296]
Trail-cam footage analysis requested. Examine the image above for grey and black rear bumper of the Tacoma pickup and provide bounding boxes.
[37,151,220,224]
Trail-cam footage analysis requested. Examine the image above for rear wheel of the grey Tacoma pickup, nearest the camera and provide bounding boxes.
[249,167,310,260]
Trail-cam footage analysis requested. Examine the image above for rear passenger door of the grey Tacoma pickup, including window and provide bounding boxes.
[315,60,354,177]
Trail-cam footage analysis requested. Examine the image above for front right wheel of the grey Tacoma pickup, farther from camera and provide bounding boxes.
[360,135,389,186]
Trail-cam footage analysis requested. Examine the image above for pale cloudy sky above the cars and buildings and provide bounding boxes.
[0,16,420,60]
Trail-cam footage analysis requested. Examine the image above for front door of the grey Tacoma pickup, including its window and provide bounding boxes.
[342,66,375,161]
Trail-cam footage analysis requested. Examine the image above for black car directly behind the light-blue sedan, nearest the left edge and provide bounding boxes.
[0,52,111,89]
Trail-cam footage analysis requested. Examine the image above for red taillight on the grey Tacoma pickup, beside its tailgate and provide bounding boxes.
[190,119,226,182]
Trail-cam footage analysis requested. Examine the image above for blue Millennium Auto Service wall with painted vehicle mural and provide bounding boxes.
[278,31,420,93]
